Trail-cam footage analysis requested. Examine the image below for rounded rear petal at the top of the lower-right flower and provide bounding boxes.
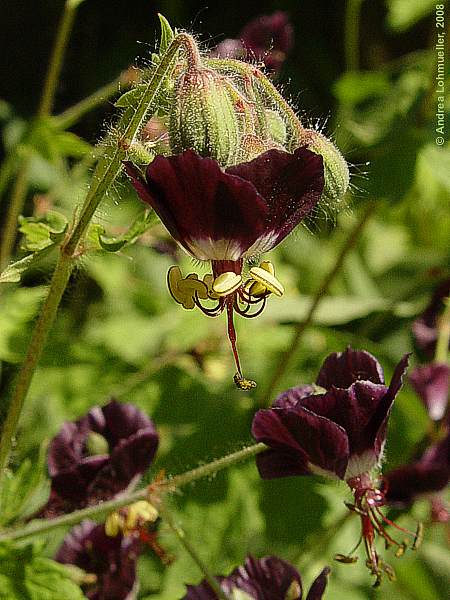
[316,348,384,390]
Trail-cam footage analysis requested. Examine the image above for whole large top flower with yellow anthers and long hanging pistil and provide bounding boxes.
[125,147,324,388]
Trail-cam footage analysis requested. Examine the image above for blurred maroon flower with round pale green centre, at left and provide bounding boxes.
[40,400,158,517]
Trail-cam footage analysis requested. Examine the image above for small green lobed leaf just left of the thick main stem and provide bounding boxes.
[19,210,68,252]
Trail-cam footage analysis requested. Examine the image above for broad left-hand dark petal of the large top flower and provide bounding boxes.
[125,150,268,260]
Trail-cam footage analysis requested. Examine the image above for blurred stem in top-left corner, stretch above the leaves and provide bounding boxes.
[37,0,80,117]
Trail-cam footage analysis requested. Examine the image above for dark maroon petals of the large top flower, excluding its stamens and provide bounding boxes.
[125,147,323,273]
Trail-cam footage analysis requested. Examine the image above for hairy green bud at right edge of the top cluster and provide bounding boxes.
[308,130,350,205]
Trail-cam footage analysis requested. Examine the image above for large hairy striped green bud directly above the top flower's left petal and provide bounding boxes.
[169,65,239,165]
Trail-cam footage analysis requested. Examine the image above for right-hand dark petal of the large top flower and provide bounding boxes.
[227,147,324,252]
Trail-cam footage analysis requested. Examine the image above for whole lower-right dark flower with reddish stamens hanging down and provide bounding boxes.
[252,348,416,584]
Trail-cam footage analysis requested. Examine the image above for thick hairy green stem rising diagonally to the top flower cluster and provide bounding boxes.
[0,34,192,484]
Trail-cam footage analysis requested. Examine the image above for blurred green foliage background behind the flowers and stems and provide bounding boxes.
[0,0,450,600]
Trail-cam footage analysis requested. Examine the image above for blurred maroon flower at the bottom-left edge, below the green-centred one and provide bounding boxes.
[55,521,140,600]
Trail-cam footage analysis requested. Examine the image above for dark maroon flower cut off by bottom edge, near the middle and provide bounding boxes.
[184,556,330,600]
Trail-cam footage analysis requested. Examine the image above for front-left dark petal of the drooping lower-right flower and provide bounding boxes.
[252,404,349,479]
